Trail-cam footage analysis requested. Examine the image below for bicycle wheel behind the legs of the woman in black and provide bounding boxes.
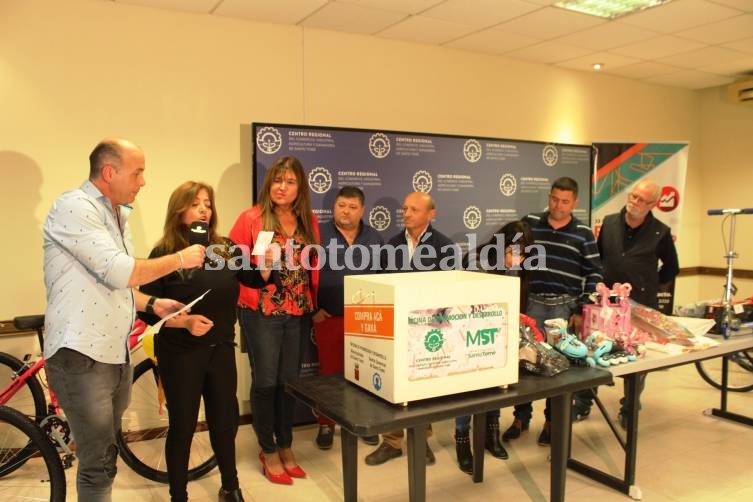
[118,359,217,483]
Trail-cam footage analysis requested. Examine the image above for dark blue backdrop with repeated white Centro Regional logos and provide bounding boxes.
[251,123,591,423]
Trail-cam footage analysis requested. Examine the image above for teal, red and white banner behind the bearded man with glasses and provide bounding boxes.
[591,143,690,315]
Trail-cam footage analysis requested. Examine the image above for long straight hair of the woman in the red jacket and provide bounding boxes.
[259,157,319,244]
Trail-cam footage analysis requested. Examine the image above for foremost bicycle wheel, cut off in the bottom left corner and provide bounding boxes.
[0,406,66,502]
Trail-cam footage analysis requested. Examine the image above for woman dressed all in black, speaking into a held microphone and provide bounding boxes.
[141,181,265,502]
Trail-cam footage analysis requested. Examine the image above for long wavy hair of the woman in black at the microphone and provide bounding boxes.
[155,181,226,254]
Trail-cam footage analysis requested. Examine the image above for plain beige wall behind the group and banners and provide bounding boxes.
[0,0,753,319]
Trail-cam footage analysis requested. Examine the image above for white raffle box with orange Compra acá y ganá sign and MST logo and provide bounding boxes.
[345,270,520,403]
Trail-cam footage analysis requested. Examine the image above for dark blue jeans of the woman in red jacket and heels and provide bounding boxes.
[238,308,311,453]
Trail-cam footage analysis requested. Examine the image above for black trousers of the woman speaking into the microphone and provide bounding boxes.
[156,335,238,501]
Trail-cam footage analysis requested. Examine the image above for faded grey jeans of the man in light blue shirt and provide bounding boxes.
[45,347,133,502]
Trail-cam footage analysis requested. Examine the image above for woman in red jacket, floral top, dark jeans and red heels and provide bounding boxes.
[230,157,319,484]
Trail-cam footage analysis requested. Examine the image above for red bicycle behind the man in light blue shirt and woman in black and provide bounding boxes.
[0,315,217,483]
